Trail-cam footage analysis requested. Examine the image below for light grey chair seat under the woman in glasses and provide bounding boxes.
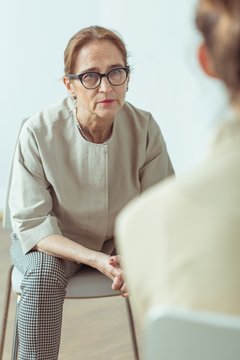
[12,266,120,299]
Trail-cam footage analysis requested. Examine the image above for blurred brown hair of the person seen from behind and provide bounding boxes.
[196,0,240,110]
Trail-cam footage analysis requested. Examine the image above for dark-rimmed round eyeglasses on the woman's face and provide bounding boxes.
[67,66,130,90]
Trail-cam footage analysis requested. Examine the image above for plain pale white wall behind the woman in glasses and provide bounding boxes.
[0,0,227,209]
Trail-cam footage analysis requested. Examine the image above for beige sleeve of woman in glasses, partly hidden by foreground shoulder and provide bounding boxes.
[140,114,174,192]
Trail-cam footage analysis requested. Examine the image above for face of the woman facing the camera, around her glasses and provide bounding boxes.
[65,40,128,121]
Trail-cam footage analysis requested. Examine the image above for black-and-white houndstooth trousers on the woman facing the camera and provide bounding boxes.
[11,234,80,360]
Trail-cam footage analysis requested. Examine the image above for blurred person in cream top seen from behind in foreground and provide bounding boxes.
[116,0,240,319]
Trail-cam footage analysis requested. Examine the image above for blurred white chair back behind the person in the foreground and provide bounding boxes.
[144,306,240,360]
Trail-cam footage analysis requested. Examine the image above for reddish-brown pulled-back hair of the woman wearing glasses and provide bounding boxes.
[64,26,127,74]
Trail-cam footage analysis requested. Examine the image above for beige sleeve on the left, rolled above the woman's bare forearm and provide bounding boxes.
[9,127,61,253]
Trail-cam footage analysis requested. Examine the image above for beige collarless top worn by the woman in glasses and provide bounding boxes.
[9,97,173,254]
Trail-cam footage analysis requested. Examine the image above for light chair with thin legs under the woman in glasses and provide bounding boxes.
[0,119,139,360]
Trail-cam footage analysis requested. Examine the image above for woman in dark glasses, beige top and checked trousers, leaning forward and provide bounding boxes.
[10,26,173,360]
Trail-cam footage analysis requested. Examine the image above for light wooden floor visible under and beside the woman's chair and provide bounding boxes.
[0,224,140,360]
